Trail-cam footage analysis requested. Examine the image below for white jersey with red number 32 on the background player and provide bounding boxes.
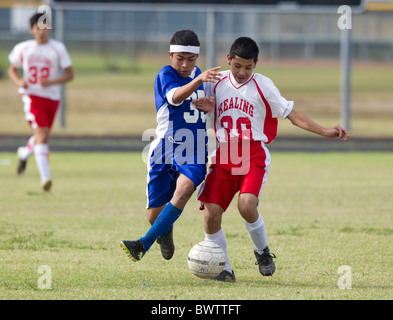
[8,39,72,100]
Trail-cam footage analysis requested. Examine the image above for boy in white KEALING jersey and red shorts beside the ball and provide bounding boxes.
[195,37,349,282]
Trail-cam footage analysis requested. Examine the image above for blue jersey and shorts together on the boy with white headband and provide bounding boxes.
[147,66,207,208]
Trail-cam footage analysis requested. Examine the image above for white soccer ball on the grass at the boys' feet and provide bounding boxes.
[187,241,225,279]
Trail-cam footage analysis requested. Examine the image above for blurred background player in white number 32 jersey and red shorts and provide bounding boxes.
[8,13,73,191]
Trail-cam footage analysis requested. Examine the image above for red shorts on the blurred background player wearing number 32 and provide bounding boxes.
[23,95,60,129]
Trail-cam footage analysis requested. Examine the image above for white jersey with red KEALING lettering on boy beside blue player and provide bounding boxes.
[204,70,293,143]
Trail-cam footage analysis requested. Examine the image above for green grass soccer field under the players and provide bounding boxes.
[0,152,393,300]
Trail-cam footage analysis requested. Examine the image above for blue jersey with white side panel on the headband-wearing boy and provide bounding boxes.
[150,66,207,164]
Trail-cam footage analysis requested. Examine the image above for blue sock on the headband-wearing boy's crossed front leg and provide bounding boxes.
[139,202,183,252]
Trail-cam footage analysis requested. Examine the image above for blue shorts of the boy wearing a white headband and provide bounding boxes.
[146,164,206,208]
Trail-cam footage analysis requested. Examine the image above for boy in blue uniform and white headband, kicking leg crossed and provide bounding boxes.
[120,30,220,261]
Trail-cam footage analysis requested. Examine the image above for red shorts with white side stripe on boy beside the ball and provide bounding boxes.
[198,143,270,211]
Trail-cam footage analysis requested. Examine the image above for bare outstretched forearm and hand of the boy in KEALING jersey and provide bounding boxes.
[287,110,349,141]
